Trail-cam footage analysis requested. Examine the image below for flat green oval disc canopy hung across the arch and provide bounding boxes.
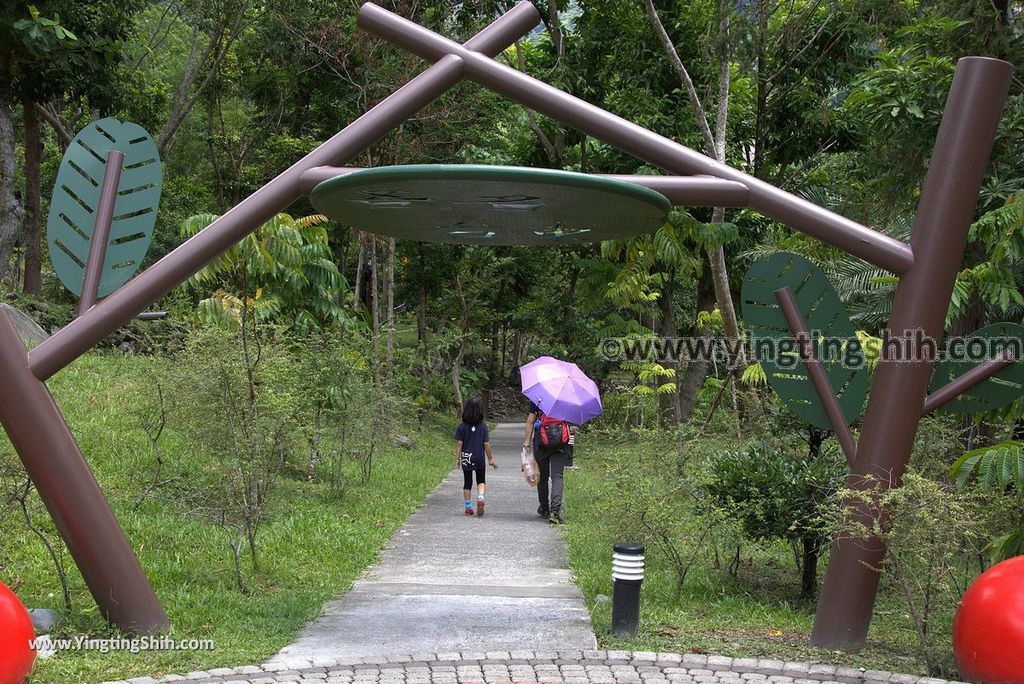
[310,164,672,245]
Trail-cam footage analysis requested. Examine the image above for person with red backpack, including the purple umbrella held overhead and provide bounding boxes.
[519,356,601,524]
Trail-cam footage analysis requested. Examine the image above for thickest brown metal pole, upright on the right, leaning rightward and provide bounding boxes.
[811,57,1013,650]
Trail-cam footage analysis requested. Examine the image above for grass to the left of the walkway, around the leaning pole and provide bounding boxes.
[0,354,451,684]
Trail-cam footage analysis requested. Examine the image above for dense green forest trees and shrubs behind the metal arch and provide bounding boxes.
[0,0,1024,672]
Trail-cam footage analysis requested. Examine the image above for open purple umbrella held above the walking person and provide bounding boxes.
[519,356,602,425]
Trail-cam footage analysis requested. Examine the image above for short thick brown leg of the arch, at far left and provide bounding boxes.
[0,310,169,634]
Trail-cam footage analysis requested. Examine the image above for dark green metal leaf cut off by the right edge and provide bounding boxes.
[930,323,1024,414]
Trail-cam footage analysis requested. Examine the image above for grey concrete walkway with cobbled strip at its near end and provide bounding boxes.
[97,425,956,684]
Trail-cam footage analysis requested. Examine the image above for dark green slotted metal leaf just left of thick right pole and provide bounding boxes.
[740,252,867,429]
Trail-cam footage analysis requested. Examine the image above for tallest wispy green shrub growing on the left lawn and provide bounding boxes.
[167,327,305,593]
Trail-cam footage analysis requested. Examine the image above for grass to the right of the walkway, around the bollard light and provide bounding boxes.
[562,436,955,675]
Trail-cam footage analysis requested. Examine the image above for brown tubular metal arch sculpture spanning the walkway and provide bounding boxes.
[0,2,1013,649]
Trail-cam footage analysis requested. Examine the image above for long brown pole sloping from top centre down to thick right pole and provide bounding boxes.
[357,2,913,273]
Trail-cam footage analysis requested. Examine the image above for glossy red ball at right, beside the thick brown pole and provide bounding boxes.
[953,556,1024,684]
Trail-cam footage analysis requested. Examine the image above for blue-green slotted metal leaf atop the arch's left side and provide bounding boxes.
[46,119,163,297]
